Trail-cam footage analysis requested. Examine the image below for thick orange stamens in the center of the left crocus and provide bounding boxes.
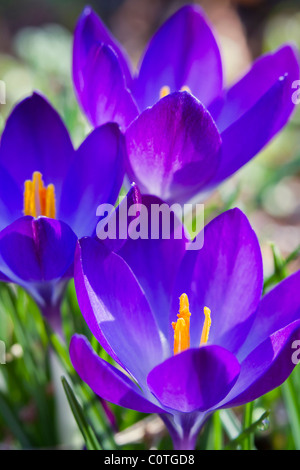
[23,171,56,219]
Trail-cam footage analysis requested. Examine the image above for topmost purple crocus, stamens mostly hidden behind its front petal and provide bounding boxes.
[73,6,299,202]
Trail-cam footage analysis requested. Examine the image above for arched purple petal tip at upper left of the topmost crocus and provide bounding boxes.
[73,7,131,92]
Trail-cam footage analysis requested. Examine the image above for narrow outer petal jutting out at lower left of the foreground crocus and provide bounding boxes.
[70,335,163,413]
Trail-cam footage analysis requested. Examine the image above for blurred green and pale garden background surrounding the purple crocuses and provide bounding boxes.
[0,0,300,449]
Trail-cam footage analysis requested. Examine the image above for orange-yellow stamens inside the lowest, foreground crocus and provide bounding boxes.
[172,294,211,354]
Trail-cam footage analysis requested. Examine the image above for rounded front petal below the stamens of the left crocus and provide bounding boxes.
[0,217,76,303]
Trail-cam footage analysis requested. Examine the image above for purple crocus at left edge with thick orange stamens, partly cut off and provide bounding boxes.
[0,93,125,325]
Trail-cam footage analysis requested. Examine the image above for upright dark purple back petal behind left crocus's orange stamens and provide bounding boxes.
[0,93,74,198]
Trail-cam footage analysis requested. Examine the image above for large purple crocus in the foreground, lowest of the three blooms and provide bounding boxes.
[70,209,300,449]
